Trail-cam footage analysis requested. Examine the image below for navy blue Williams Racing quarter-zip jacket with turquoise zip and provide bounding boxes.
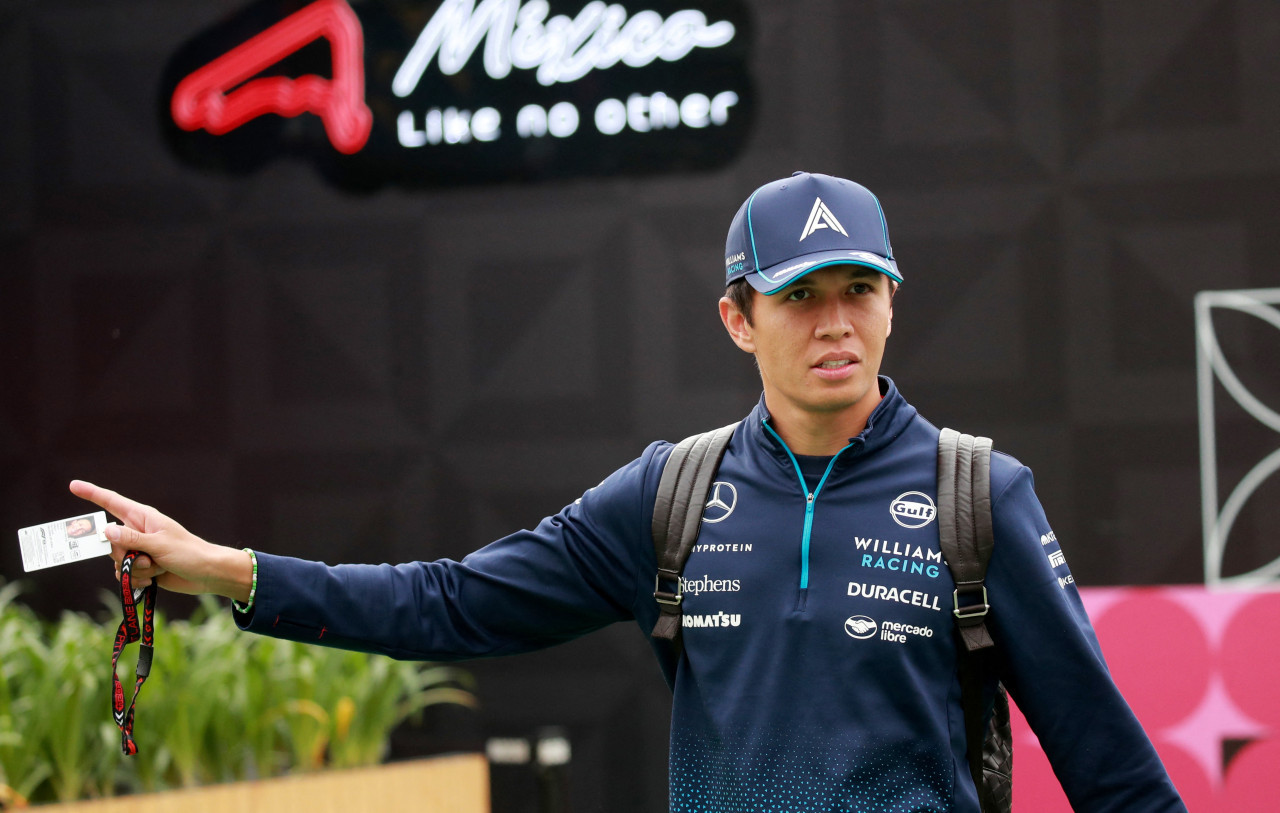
[237,378,1185,813]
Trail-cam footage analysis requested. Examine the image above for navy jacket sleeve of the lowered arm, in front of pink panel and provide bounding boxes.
[987,457,1187,813]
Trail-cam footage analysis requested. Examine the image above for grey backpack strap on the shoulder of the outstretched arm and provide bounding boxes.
[652,421,741,641]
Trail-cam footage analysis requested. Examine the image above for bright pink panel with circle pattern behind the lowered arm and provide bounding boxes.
[1014,586,1280,813]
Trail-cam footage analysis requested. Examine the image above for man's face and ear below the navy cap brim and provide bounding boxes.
[721,265,893,425]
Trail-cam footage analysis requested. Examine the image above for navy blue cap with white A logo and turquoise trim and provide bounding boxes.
[724,172,902,293]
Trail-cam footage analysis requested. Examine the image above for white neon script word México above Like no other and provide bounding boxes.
[392,0,735,97]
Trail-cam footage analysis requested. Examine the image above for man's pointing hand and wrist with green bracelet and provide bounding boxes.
[70,480,253,602]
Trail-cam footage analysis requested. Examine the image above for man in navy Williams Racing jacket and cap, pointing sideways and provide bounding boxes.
[72,173,1185,813]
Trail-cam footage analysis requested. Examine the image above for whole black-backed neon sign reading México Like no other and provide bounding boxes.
[159,0,754,188]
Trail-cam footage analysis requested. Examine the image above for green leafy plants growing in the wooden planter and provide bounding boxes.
[0,584,476,803]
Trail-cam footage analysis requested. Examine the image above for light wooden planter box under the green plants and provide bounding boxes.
[36,754,489,813]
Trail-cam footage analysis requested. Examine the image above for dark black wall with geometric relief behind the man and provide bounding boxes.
[0,0,1280,813]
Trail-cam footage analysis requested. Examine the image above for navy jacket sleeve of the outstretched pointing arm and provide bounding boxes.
[236,443,662,661]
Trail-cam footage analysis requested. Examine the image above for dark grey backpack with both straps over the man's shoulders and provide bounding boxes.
[652,423,1014,813]
